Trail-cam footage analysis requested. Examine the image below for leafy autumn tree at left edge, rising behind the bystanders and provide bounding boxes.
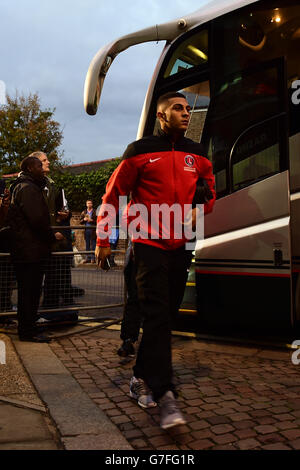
[0,93,63,174]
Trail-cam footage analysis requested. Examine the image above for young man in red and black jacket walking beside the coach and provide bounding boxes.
[95,92,215,429]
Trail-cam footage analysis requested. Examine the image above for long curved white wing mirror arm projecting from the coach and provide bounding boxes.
[84,12,199,115]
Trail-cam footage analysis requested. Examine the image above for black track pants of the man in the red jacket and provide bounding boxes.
[134,243,191,400]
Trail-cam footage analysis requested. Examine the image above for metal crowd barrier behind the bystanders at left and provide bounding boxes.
[0,226,125,319]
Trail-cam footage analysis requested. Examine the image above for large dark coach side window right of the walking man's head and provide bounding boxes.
[204,61,282,197]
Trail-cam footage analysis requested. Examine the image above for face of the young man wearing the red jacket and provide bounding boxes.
[157,98,191,133]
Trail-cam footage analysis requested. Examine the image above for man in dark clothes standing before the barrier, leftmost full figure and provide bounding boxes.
[7,156,64,343]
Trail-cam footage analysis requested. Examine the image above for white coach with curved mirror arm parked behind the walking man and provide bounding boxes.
[84,0,300,332]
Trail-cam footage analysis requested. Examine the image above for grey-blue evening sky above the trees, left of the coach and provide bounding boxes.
[0,0,206,163]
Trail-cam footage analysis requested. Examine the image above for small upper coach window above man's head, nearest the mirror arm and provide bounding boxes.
[164,30,208,78]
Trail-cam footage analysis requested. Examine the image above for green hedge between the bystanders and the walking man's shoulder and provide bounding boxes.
[50,158,121,211]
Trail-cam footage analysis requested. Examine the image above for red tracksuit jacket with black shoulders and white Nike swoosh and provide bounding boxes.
[97,132,215,250]
